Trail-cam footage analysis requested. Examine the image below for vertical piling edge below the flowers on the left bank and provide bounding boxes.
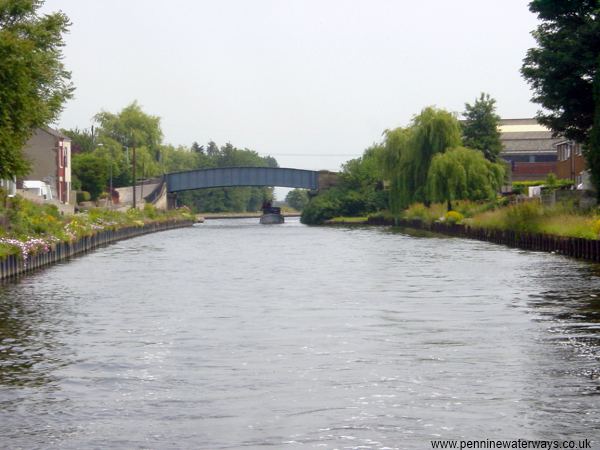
[0,220,194,280]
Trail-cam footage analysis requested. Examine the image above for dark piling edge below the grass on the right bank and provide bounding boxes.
[368,219,600,262]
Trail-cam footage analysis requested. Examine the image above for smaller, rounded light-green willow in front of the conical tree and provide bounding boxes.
[427,147,504,211]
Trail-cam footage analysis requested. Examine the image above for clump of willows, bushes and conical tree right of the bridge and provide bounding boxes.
[302,94,506,223]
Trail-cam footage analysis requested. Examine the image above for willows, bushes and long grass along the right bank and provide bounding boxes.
[301,95,600,243]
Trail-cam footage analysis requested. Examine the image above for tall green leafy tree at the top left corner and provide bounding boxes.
[0,0,73,178]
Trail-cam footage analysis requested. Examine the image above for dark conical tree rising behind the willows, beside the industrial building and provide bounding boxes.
[462,92,502,162]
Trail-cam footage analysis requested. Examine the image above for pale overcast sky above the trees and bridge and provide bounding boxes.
[43,0,538,174]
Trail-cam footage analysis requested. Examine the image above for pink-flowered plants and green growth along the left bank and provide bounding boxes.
[0,190,194,260]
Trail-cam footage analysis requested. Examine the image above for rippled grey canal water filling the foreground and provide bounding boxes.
[0,219,600,449]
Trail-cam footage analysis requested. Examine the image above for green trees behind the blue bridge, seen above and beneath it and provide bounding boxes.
[62,102,277,212]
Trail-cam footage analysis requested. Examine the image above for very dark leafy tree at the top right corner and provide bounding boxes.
[521,0,600,188]
